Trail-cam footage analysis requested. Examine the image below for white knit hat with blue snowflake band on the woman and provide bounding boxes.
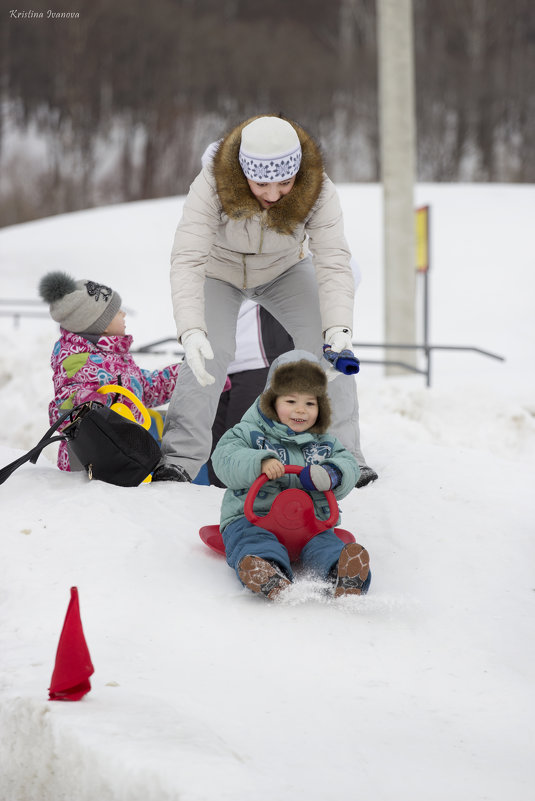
[239,117,302,183]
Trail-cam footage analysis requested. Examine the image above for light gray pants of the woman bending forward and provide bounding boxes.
[162,257,366,479]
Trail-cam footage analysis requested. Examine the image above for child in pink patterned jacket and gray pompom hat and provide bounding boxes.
[39,272,180,470]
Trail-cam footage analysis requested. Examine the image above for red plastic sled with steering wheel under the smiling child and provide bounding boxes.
[199,465,355,562]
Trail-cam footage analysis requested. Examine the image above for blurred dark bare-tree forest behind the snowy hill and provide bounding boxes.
[0,0,535,224]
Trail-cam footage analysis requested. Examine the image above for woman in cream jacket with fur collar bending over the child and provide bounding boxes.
[153,116,374,488]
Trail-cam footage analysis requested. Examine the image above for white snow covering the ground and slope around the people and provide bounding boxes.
[0,185,535,801]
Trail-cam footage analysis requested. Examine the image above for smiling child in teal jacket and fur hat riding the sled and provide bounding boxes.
[212,350,371,599]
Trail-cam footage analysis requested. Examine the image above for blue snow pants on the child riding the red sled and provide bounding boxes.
[223,517,352,581]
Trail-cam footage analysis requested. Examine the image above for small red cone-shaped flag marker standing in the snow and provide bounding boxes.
[48,587,95,701]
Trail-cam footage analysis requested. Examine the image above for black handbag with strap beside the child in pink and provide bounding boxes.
[0,401,162,487]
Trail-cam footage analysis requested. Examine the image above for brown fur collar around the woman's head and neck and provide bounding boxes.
[213,115,323,234]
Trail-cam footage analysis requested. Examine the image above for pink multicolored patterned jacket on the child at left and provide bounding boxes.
[48,328,180,470]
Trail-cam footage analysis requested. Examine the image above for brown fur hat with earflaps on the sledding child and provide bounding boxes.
[258,357,331,434]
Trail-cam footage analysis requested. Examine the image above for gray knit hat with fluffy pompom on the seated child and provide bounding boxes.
[39,272,122,336]
